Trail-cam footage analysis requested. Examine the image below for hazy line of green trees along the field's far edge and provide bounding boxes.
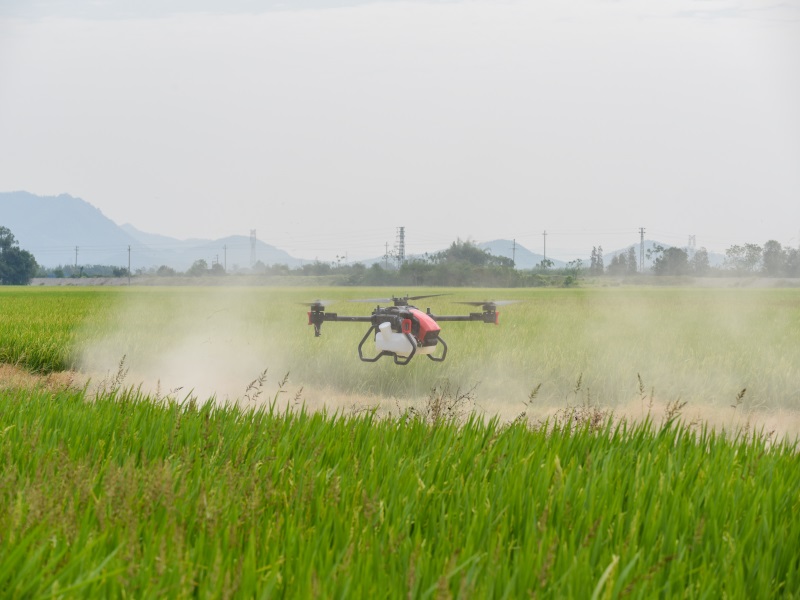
[6,226,800,287]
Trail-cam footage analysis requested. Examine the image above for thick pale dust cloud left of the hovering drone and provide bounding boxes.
[79,288,286,402]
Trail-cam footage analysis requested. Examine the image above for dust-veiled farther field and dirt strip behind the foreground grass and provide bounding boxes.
[0,287,800,433]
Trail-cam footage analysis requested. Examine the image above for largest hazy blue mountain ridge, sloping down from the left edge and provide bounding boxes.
[0,192,307,271]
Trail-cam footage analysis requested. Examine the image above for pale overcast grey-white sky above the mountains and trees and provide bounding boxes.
[0,0,800,261]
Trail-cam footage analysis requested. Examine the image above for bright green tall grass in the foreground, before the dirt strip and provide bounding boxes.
[0,380,800,598]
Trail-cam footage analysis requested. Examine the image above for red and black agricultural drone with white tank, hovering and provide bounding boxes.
[308,294,513,366]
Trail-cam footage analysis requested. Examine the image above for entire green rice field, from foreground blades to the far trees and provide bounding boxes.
[0,288,800,598]
